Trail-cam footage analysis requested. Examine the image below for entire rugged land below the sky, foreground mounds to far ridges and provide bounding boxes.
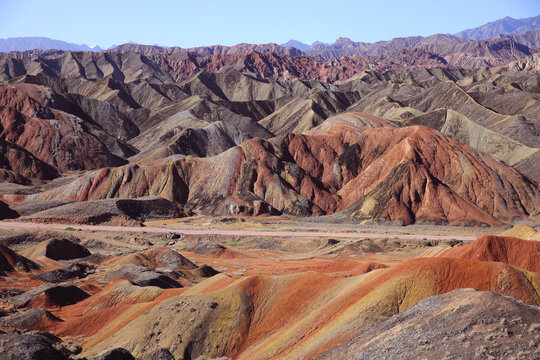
[0,9,540,360]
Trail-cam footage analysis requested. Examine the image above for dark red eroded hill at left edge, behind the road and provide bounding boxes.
[0,84,130,174]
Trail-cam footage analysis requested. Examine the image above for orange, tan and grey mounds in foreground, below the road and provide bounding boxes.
[0,229,540,359]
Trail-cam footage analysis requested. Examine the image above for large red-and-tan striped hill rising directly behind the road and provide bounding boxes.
[23,117,540,225]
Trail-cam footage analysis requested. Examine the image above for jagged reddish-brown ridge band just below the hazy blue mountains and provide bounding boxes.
[0,38,535,83]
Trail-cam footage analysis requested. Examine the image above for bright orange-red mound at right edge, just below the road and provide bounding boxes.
[441,236,540,273]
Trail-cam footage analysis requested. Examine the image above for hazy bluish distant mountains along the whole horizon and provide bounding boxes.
[4,15,540,60]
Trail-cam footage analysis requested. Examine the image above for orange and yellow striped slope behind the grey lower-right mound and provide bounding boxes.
[67,258,540,359]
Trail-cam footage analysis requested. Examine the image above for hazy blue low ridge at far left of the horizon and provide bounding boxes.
[0,37,101,52]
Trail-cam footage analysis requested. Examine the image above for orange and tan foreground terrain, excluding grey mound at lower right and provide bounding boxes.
[0,221,540,359]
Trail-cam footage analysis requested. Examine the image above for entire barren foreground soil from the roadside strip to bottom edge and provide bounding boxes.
[0,224,540,359]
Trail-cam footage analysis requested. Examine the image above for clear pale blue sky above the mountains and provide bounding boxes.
[0,0,540,48]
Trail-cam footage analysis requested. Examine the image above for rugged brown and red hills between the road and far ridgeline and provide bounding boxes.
[0,49,540,226]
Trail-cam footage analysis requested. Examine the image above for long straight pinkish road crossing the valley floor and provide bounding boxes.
[0,221,477,241]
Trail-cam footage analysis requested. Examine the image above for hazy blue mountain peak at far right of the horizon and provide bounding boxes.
[455,15,540,40]
